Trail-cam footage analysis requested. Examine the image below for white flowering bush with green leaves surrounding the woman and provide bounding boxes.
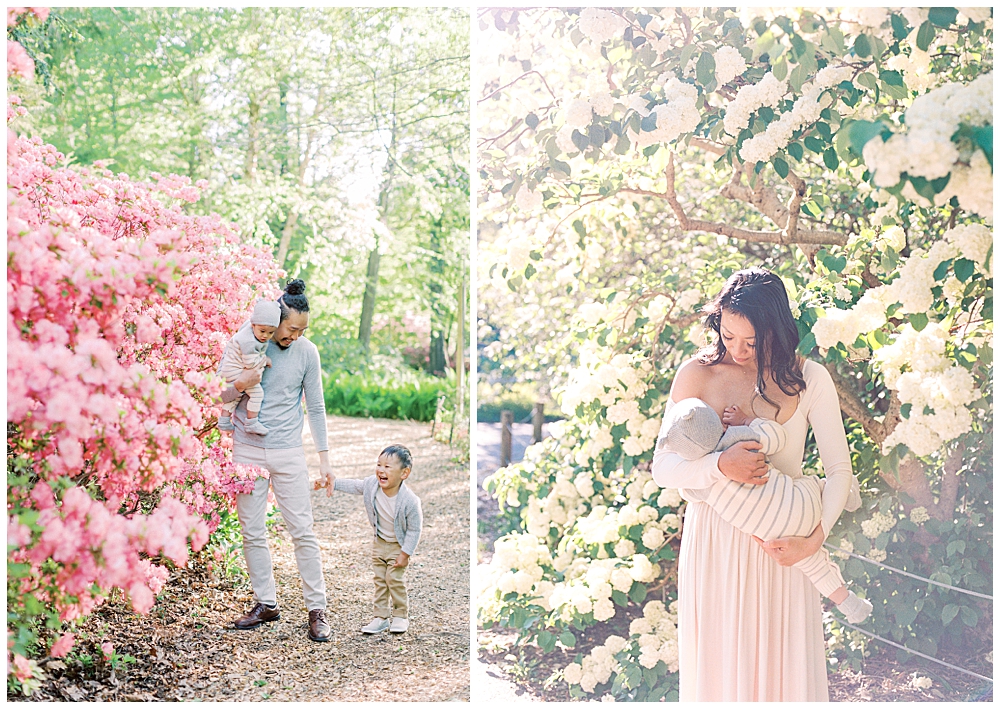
[477,8,993,697]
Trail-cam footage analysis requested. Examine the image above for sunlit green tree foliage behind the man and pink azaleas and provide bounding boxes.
[24,7,469,382]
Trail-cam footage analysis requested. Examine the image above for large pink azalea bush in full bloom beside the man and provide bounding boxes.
[7,8,279,687]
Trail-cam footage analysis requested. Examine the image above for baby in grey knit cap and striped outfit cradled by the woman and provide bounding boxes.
[658,399,872,623]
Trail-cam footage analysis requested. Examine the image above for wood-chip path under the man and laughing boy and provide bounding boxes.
[21,416,470,702]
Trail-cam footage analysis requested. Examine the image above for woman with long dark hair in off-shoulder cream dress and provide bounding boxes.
[653,268,854,701]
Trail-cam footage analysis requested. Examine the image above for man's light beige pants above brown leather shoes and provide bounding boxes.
[233,443,326,610]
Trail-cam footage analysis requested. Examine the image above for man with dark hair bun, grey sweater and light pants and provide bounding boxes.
[222,279,334,642]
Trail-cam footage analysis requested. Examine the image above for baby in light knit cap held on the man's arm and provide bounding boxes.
[218,300,281,436]
